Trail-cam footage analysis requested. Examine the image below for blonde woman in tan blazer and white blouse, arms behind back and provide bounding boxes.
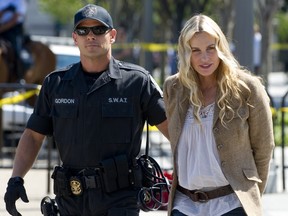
[164,14,274,216]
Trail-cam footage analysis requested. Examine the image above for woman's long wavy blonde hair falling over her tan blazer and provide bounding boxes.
[178,14,250,126]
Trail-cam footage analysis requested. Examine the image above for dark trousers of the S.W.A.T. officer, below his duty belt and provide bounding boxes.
[56,186,139,216]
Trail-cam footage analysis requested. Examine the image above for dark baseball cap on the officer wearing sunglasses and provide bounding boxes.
[74,4,113,29]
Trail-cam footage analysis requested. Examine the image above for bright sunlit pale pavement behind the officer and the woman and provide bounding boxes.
[0,148,288,216]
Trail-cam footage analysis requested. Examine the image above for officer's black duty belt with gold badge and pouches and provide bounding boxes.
[52,155,142,196]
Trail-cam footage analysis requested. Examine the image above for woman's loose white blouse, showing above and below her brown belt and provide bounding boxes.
[173,103,241,216]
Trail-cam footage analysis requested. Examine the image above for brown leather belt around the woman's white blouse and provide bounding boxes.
[177,185,234,203]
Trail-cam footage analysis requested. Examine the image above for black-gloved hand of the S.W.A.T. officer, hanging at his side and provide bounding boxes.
[4,177,29,216]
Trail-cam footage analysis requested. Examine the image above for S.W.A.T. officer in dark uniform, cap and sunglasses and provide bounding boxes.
[4,4,168,216]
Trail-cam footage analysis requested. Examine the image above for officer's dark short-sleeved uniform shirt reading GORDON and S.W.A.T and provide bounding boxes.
[27,58,166,168]
